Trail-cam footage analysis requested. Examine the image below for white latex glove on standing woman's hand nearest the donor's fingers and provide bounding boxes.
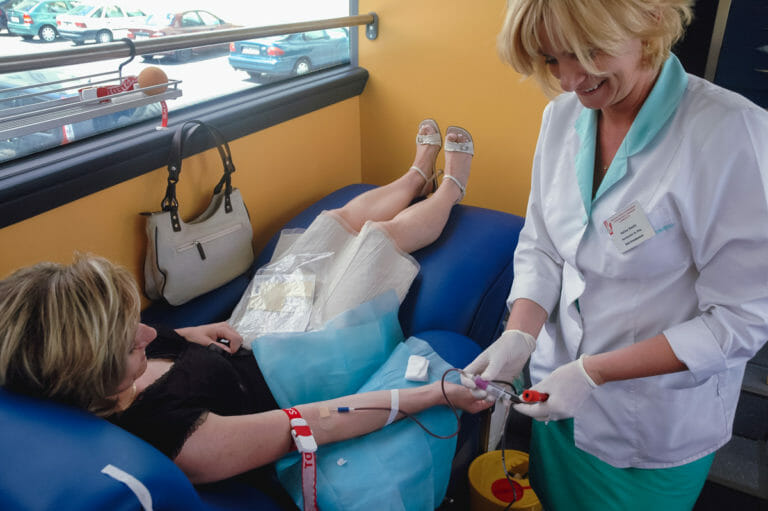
[461,330,536,399]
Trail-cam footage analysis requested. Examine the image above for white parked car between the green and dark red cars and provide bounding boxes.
[56,3,147,44]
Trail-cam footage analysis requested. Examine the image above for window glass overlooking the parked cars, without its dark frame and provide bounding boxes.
[0,0,350,164]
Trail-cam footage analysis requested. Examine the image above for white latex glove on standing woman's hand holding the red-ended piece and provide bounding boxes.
[513,355,597,421]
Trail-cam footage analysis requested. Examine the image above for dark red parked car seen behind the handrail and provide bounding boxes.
[128,10,239,62]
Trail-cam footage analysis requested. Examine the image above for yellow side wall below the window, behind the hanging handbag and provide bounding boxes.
[0,98,360,290]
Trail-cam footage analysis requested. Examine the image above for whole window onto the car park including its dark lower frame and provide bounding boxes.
[0,0,367,227]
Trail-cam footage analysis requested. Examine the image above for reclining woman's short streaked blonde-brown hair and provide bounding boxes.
[0,255,141,415]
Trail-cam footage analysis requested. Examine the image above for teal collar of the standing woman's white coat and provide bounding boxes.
[574,55,688,215]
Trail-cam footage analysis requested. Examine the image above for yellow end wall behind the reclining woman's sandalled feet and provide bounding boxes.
[359,0,547,215]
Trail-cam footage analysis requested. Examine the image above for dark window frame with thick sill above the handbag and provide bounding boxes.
[0,0,368,228]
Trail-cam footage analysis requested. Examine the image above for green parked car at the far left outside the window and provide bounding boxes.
[7,0,78,43]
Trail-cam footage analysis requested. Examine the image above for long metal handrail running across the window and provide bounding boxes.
[0,13,378,74]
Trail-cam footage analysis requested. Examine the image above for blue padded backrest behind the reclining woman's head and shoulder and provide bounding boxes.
[0,388,208,511]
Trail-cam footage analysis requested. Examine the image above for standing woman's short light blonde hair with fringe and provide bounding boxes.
[498,0,693,95]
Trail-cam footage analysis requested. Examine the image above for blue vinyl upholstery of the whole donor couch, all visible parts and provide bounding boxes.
[0,185,523,511]
